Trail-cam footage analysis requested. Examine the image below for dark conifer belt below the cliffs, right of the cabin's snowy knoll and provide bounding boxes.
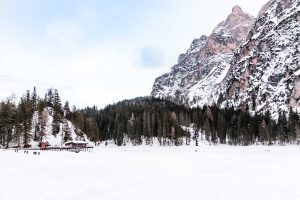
[82,97,300,145]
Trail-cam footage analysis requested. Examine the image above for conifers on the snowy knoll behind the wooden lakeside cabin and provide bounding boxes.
[0,87,89,147]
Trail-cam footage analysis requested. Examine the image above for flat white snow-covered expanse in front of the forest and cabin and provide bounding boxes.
[0,145,300,200]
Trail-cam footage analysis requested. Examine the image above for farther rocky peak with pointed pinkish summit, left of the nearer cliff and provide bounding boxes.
[151,6,255,106]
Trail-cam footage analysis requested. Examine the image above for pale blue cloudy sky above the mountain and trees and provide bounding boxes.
[0,0,265,107]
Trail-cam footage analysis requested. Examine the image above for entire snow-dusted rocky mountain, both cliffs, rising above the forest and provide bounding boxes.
[151,0,300,119]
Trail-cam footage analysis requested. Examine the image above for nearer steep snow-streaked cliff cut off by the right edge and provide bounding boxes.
[223,0,300,118]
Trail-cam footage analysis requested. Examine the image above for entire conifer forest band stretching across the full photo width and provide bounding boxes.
[0,88,300,147]
